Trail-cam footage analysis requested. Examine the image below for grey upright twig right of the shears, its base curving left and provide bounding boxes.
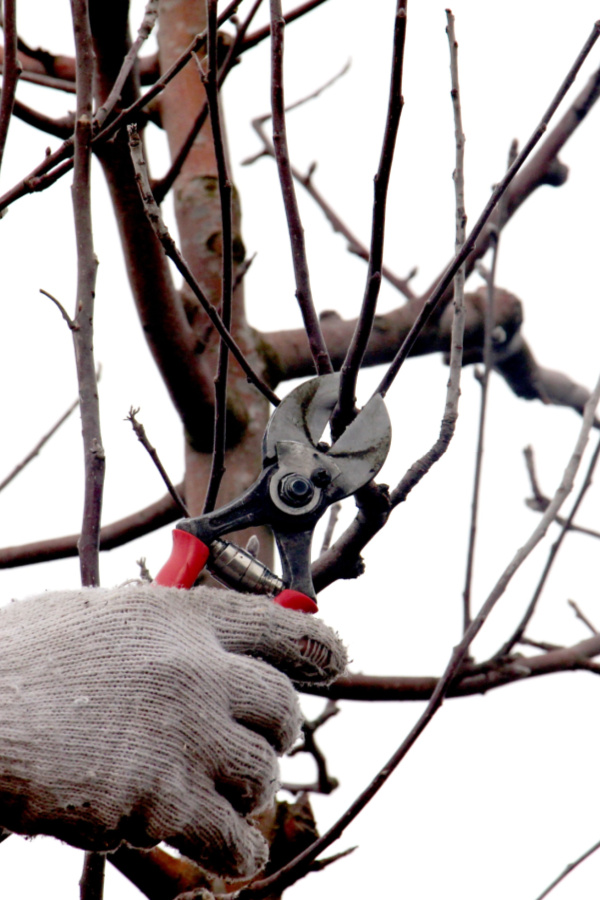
[390,10,467,512]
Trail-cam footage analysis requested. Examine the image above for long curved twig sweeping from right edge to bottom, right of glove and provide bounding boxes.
[242,370,600,897]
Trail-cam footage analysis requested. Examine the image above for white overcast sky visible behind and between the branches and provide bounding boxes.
[0,0,600,900]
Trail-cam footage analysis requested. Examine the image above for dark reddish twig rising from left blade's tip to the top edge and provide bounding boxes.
[270,0,333,375]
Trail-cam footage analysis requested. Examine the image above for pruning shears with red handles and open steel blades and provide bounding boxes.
[156,374,391,613]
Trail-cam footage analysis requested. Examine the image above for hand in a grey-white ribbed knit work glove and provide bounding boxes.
[0,585,346,877]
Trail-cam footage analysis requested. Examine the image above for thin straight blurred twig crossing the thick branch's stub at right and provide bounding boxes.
[463,141,517,631]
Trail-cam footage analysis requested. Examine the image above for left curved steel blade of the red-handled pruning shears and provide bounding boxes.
[263,372,340,459]
